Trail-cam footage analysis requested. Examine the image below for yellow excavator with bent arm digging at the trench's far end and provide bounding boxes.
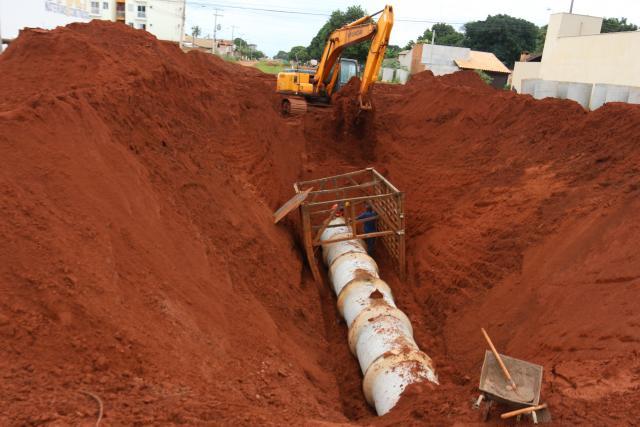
[276,5,393,115]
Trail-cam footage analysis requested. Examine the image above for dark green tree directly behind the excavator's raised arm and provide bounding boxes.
[307,6,371,64]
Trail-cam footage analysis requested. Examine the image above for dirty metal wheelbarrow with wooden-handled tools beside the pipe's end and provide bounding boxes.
[474,331,551,424]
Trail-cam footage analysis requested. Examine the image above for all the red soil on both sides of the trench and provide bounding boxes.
[0,21,640,425]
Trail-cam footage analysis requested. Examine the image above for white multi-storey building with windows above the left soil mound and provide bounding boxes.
[89,0,186,42]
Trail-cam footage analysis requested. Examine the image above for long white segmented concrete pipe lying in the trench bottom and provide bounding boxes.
[321,218,438,415]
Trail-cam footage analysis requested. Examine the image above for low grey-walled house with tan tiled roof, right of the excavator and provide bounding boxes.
[398,43,511,88]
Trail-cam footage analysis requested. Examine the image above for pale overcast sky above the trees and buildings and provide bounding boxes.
[0,0,640,56]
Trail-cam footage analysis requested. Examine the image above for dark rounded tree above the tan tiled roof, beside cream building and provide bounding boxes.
[464,15,538,67]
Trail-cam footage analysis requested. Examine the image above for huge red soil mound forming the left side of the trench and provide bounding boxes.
[0,21,357,425]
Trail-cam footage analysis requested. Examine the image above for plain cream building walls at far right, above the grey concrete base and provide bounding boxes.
[513,13,640,89]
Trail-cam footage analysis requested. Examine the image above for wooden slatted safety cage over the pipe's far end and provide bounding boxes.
[293,168,406,281]
